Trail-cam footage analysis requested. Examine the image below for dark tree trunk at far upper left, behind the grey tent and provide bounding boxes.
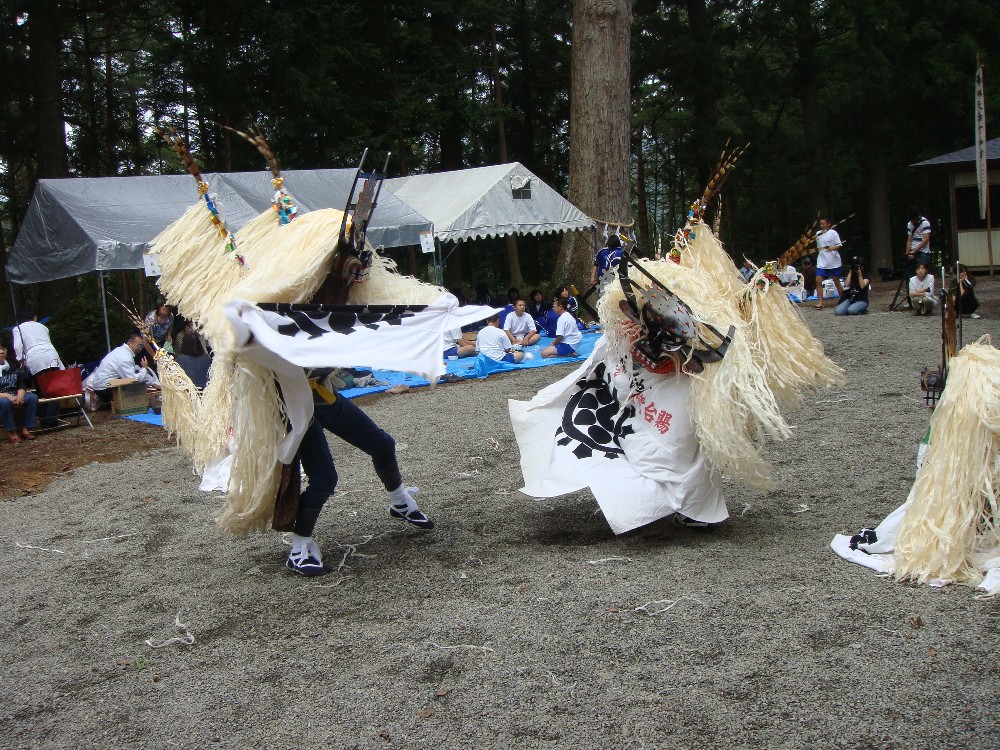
[28,0,69,179]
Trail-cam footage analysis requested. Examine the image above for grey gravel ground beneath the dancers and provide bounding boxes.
[0,282,1000,750]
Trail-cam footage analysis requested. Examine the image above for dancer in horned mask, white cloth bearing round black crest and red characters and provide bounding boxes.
[510,148,844,534]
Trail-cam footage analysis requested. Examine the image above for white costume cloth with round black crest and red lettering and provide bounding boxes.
[508,337,728,534]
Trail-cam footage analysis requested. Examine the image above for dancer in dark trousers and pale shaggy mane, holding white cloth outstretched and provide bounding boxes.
[154,130,493,576]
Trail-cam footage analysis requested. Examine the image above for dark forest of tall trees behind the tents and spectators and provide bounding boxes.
[0,0,1000,361]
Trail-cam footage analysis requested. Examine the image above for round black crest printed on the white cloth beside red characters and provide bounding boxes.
[556,363,635,459]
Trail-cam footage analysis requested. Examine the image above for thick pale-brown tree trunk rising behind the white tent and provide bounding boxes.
[555,0,632,285]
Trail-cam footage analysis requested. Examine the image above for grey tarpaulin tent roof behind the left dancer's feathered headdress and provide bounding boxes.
[7,169,431,284]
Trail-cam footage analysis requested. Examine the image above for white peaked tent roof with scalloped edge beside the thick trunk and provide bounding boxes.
[385,162,594,242]
